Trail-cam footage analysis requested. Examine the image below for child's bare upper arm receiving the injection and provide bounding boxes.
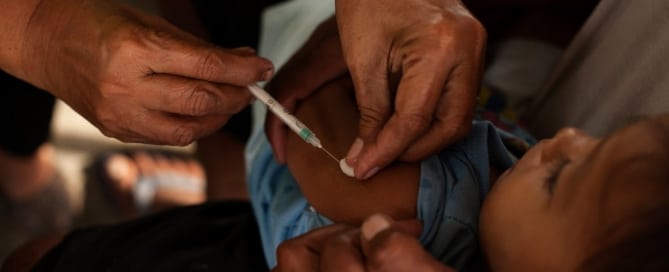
[286,78,420,225]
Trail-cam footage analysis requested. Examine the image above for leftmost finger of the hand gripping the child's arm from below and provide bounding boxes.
[275,224,351,271]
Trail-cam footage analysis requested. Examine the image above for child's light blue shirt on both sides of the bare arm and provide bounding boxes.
[246,114,515,270]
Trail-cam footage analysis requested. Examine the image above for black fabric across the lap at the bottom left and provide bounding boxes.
[34,201,268,271]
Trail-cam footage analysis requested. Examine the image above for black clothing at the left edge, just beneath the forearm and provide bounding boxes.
[0,70,56,157]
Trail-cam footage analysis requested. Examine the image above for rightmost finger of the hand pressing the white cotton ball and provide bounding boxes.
[400,67,479,161]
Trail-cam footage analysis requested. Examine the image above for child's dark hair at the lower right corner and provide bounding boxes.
[580,121,669,271]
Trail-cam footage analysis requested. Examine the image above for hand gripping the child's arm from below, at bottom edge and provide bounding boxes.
[273,215,454,272]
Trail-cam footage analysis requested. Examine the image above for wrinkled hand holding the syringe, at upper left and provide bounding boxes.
[23,0,273,145]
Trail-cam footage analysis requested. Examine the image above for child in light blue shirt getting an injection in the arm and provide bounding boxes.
[247,76,669,271]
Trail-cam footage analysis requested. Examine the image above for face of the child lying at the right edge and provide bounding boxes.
[480,115,669,271]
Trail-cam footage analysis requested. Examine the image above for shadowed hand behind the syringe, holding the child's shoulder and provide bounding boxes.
[265,17,348,163]
